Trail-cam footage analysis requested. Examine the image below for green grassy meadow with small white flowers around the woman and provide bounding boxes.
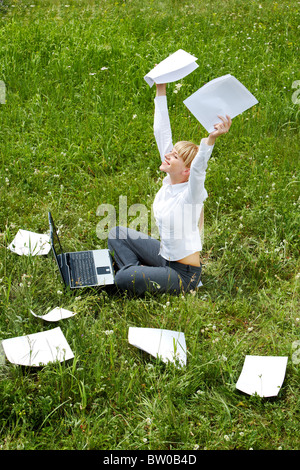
[0,0,300,455]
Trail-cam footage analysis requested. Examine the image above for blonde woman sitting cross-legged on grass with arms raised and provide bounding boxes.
[108,84,231,295]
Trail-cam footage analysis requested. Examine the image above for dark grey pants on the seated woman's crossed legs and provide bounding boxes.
[108,227,201,295]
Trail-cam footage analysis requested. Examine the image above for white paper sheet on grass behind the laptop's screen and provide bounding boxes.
[7,229,51,256]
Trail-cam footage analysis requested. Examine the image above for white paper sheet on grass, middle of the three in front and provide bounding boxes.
[128,327,186,366]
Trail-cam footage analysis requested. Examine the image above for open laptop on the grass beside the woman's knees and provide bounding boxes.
[48,212,114,289]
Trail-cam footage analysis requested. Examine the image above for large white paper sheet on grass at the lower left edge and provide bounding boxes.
[2,327,74,366]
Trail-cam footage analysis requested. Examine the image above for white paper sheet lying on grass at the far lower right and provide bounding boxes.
[236,356,288,397]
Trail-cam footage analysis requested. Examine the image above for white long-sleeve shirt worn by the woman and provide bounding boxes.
[153,96,213,261]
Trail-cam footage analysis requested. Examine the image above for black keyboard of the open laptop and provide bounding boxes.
[69,251,98,287]
